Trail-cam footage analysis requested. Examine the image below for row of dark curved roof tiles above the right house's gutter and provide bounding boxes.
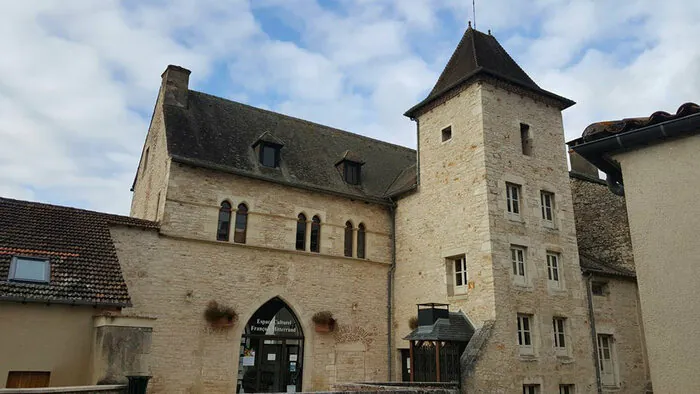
[581,103,700,142]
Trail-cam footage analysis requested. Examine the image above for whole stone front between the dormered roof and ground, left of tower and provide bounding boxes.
[123,157,391,393]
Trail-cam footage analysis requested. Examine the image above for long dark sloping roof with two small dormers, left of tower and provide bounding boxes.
[164,90,416,203]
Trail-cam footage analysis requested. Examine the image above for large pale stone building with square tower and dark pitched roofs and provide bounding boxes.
[0,27,648,394]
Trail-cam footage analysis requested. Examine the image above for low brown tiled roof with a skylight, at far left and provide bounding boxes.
[0,198,158,306]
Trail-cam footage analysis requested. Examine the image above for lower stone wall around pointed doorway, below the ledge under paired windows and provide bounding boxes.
[112,222,389,394]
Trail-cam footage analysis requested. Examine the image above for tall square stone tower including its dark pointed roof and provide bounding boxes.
[393,27,595,393]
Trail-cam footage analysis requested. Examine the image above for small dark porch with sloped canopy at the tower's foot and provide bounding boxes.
[404,303,475,382]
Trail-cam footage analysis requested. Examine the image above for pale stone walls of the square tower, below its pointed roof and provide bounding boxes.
[394,83,595,393]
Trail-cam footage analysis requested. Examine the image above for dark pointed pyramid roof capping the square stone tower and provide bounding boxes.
[404,25,575,117]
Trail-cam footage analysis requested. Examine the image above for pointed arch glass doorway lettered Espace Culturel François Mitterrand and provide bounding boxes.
[237,297,304,393]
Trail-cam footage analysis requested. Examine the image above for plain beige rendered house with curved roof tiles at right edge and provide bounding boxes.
[569,103,700,393]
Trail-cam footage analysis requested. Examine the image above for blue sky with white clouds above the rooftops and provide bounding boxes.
[0,0,700,214]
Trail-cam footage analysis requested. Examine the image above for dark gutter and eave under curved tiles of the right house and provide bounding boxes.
[571,113,700,195]
